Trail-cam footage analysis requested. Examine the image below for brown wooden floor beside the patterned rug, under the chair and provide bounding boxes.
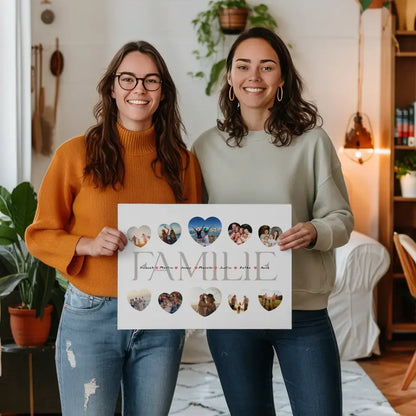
[357,350,416,416]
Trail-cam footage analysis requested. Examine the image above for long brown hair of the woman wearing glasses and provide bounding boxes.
[84,41,189,202]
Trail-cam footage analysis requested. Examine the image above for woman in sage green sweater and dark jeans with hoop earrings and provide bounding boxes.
[194,28,353,416]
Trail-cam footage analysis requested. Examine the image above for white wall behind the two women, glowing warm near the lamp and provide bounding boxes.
[32,0,383,237]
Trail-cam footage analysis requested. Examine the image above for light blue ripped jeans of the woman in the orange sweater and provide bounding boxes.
[56,285,185,416]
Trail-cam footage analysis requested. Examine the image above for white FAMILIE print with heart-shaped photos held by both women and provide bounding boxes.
[117,204,292,329]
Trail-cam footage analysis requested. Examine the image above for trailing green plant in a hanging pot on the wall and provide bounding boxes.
[189,0,277,95]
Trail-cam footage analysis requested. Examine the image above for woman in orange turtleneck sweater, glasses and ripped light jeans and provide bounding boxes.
[26,41,201,416]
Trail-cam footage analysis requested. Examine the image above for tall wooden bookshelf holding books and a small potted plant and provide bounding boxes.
[378,20,416,341]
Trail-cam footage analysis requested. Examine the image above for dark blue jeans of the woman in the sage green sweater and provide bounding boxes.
[207,309,342,416]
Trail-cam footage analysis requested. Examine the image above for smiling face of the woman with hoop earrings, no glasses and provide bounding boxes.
[228,38,284,118]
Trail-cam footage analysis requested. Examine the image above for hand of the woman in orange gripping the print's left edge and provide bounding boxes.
[75,227,127,257]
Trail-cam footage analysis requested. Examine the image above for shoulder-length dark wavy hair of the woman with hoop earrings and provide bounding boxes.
[217,27,322,147]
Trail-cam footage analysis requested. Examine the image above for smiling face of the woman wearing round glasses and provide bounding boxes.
[111,51,163,131]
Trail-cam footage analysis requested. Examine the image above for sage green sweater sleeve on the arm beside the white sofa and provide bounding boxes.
[311,134,354,251]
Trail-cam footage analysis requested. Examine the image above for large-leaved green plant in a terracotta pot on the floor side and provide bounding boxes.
[0,182,64,346]
